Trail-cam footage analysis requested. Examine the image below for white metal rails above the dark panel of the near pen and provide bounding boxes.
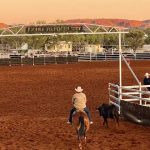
[108,83,150,113]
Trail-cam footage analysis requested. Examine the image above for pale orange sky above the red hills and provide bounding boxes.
[0,0,150,24]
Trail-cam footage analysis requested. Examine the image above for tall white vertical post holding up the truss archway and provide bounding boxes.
[119,33,122,113]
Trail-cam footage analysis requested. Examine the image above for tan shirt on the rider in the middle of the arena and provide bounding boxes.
[72,92,87,110]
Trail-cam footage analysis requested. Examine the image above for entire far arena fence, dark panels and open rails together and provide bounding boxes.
[0,53,150,66]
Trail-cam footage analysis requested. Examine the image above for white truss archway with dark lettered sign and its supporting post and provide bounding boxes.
[0,23,128,99]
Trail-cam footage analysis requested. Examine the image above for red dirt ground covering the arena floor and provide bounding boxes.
[0,61,150,150]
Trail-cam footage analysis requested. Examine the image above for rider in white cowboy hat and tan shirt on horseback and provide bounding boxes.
[67,86,93,124]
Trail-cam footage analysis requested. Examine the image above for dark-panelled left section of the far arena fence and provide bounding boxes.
[0,55,78,66]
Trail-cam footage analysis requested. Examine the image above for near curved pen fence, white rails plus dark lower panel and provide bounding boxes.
[108,83,150,125]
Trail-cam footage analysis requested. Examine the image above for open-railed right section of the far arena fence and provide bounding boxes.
[78,53,150,61]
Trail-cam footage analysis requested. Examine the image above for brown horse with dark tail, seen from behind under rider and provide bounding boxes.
[72,110,90,149]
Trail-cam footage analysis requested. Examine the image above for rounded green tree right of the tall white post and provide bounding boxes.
[125,29,145,52]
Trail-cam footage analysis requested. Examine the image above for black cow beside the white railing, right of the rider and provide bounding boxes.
[96,103,119,128]
